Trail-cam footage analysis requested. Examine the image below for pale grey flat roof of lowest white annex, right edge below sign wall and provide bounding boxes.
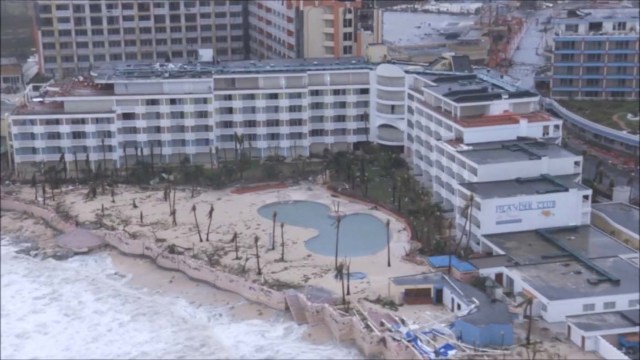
[511,257,640,300]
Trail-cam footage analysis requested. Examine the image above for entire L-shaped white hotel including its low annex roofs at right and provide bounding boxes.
[9,58,640,338]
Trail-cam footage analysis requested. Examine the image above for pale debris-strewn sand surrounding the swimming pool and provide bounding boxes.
[7,185,429,300]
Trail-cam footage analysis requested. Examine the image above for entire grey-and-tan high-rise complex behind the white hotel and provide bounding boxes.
[33,0,382,78]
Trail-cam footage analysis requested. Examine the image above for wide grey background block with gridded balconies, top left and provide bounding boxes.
[34,0,249,78]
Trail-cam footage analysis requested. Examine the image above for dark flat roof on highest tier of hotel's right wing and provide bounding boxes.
[421,74,538,103]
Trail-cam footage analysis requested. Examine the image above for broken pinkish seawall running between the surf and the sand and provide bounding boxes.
[1,196,422,360]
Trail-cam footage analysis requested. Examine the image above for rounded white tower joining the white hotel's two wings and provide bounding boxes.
[371,64,406,146]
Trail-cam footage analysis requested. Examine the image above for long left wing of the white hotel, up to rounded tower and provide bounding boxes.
[11,58,372,171]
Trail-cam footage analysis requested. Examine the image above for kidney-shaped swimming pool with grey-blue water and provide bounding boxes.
[258,201,387,258]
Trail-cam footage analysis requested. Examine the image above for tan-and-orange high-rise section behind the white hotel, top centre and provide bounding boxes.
[249,0,382,59]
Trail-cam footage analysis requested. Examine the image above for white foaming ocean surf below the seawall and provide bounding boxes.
[0,236,362,359]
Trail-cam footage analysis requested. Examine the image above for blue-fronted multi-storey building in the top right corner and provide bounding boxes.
[551,8,640,99]
